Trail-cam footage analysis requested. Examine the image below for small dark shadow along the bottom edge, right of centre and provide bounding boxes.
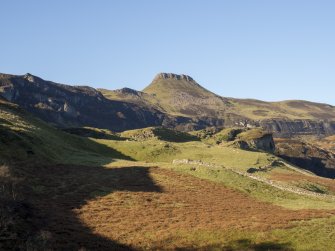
[176,239,294,251]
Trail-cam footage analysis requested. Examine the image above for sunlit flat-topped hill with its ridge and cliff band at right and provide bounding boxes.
[102,73,335,137]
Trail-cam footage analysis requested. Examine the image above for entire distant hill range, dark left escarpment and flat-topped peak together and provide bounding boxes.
[0,73,335,137]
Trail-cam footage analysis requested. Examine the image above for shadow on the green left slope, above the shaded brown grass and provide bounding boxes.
[0,124,134,165]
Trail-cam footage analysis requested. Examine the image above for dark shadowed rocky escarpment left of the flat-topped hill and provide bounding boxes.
[0,74,164,131]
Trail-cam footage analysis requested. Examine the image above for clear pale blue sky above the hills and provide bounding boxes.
[0,0,335,105]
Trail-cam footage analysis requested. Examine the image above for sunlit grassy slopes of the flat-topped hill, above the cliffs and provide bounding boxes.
[102,74,335,120]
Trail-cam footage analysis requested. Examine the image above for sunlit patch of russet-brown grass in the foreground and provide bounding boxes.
[75,168,335,249]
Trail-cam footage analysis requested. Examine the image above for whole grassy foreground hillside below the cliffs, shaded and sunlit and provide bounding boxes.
[0,100,335,250]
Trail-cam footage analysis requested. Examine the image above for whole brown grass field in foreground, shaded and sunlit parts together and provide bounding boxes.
[5,162,335,250]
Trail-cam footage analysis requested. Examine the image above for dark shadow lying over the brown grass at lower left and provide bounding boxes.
[0,165,162,250]
